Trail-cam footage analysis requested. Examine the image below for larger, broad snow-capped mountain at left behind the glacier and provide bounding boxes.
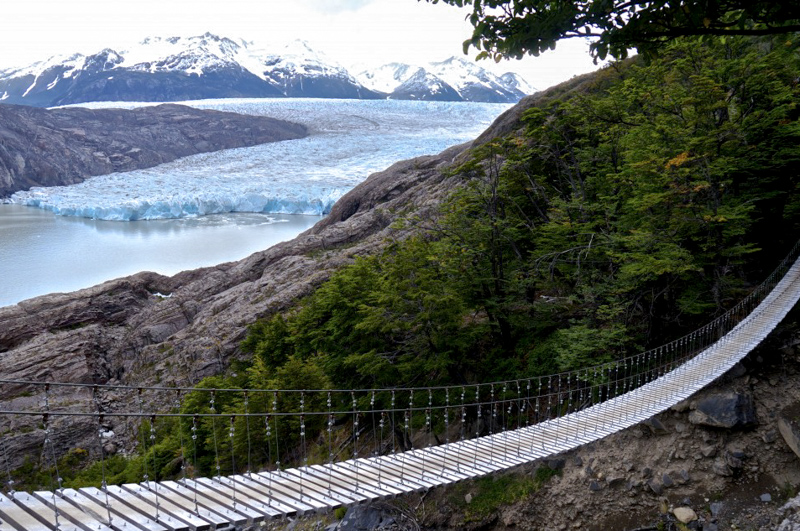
[0,33,383,106]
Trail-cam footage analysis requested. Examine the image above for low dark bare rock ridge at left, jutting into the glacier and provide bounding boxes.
[0,105,307,198]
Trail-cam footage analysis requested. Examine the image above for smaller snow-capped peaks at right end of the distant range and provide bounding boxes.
[357,57,534,103]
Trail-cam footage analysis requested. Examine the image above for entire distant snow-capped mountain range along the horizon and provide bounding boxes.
[0,33,527,107]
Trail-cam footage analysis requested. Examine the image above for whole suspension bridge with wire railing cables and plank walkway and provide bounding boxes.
[0,243,800,531]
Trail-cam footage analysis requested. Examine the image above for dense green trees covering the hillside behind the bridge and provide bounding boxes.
[244,36,800,388]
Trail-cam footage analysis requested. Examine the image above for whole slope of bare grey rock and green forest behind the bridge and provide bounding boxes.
[0,37,800,494]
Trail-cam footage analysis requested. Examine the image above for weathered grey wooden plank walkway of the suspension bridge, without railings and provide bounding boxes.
[0,261,800,531]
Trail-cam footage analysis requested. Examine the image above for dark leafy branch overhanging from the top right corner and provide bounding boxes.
[428,0,800,60]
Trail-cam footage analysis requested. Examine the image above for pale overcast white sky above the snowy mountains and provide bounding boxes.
[0,0,597,90]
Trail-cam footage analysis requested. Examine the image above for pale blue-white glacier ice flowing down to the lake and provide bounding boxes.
[10,98,510,221]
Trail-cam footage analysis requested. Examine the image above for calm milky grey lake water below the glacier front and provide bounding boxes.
[0,204,321,307]
